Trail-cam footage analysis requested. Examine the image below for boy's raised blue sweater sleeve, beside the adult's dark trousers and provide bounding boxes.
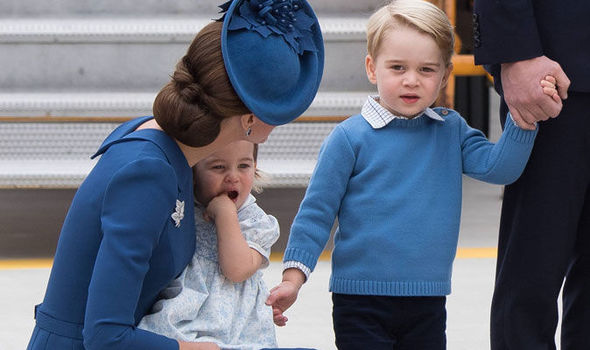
[460,117,538,185]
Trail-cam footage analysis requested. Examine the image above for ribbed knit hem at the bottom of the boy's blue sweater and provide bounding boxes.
[330,276,451,296]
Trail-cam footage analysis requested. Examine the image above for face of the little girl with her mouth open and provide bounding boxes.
[193,141,256,208]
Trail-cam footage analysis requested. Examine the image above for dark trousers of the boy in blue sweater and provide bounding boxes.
[332,293,447,350]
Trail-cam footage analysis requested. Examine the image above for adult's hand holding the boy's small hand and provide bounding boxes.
[501,56,570,130]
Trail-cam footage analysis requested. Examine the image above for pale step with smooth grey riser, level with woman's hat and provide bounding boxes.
[0,17,371,92]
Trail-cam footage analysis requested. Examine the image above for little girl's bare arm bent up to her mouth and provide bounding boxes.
[206,193,263,283]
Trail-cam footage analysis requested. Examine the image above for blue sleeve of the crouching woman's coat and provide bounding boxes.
[83,158,178,350]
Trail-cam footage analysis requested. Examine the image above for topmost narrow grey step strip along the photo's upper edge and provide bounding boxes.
[0,0,384,18]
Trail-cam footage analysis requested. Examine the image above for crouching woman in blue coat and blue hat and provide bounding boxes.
[28,0,323,350]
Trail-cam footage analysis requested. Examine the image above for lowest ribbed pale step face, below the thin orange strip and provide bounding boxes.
[0,117,337,189]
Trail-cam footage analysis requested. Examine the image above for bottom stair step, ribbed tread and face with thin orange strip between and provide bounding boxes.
[0,92,368,188]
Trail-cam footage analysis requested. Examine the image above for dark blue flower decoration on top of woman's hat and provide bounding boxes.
[219,0,318,55]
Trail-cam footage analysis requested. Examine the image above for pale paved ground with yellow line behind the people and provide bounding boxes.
[0,178,508,350]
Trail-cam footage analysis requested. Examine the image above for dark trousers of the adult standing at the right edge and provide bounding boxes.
[491,92,590,350]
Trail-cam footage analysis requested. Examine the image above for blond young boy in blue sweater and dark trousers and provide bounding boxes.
[267,0,557,350]
